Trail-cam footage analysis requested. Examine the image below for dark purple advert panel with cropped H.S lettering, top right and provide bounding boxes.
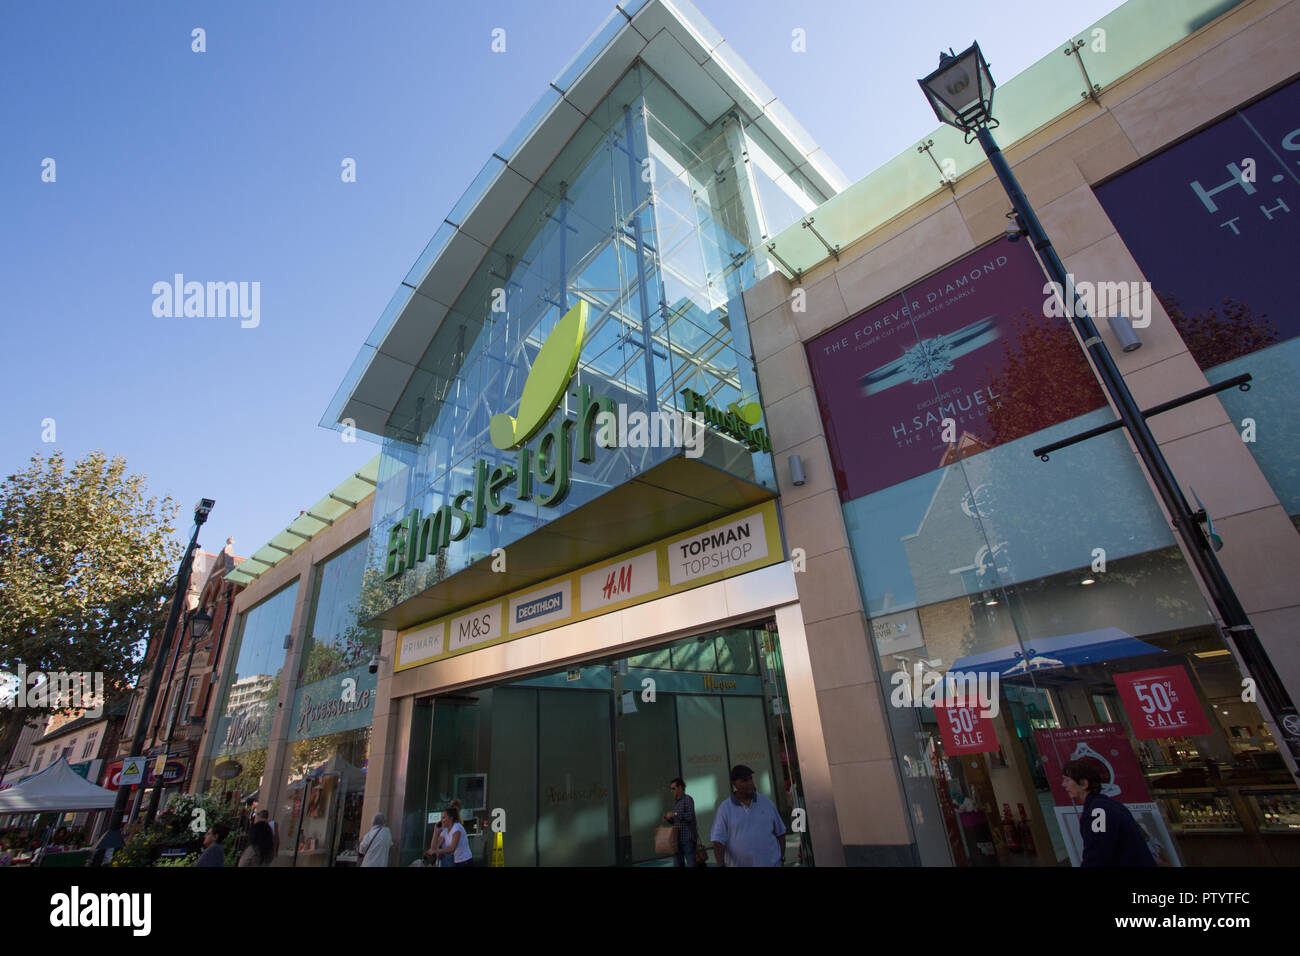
[1096,76,1300,368]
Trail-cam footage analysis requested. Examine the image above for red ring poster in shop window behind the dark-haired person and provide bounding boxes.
[1034,723,1182,866]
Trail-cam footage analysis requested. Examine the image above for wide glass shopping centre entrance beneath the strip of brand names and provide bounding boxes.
[399,620,813,866]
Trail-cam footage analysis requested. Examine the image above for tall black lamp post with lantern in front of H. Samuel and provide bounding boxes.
[917,43,1300,777]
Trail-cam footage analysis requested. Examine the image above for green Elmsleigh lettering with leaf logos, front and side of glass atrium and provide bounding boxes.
[385,300,772,580]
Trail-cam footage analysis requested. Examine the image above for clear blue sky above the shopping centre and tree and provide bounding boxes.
[0,0,1118,555]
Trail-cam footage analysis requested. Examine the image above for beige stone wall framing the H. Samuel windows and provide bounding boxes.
[745,0,1300,845]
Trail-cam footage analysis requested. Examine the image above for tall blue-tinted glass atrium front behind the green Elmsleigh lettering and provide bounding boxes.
[372,64,820,605]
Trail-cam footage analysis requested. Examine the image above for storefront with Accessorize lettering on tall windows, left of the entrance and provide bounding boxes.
[194,457,380,866]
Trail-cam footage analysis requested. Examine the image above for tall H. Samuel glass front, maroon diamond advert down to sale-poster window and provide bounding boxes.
[807,231,1300,866]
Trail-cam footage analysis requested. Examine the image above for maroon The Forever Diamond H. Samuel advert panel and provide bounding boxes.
[807,239,1105,501]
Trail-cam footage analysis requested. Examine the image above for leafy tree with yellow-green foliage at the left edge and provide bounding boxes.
[0,449,182,760]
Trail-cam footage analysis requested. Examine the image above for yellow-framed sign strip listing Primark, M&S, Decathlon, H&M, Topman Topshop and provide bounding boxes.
[394,501,785,671]
